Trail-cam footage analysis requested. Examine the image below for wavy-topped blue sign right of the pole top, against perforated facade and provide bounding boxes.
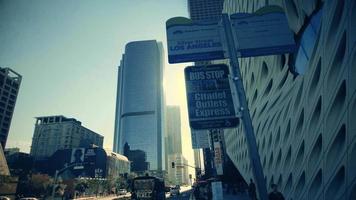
[230,6,297,57]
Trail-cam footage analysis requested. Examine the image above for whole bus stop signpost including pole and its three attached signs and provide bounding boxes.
[167,6,297,200]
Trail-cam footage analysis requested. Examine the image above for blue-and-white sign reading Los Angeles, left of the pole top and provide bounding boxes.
[166,17,225,63]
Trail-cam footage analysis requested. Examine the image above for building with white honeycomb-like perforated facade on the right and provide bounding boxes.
[224,0,356,200]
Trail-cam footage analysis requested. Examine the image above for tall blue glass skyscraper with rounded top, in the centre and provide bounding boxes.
[113,40,165,171]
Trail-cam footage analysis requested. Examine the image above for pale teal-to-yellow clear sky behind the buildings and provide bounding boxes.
[0,0,192,165]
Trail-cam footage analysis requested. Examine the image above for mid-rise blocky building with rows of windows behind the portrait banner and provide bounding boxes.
[30,115,104,159]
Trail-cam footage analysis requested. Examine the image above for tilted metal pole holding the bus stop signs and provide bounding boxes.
[222,14,268,200]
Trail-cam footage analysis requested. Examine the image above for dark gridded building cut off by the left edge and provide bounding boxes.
[0,67,22,149]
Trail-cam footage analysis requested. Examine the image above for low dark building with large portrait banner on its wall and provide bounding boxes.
[46,147,130,180]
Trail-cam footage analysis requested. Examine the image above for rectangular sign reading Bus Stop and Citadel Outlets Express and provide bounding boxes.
[184,64,239,129]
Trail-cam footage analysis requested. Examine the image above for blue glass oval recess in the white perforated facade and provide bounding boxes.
[291,9,322,75]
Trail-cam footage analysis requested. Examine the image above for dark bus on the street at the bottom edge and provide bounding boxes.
[131,176,166,200]
